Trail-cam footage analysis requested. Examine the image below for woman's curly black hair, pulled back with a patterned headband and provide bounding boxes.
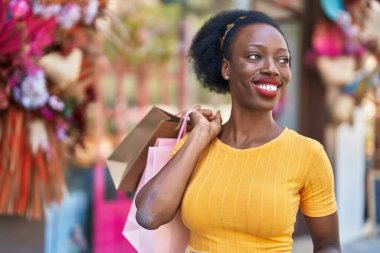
[189,10,287,93]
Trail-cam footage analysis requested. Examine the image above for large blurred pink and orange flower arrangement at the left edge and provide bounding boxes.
[0,0,106,218]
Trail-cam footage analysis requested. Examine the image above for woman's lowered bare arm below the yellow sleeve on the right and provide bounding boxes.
[304,212,341,253]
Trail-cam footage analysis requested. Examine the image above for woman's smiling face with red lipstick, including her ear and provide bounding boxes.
[222,24,291,111]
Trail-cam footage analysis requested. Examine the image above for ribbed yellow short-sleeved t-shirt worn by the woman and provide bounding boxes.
[173,128,337,253]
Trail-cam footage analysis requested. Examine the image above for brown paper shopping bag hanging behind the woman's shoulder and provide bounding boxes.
[106,107,180,192]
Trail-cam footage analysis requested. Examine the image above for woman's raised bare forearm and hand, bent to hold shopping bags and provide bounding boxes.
[136,109,222,229]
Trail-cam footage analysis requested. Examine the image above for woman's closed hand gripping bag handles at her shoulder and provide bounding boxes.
[190,106,222,142]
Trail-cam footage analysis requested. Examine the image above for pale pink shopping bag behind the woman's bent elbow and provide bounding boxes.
[123,111,191,253]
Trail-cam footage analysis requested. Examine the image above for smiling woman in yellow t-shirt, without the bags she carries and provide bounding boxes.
[136,10,340,252]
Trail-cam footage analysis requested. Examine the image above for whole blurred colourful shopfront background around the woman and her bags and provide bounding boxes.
[0,0,380,253]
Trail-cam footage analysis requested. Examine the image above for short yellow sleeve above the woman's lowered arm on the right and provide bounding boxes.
[301,144,337,217]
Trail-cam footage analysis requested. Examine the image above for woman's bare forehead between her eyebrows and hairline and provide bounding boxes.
[233,24,288,50]
